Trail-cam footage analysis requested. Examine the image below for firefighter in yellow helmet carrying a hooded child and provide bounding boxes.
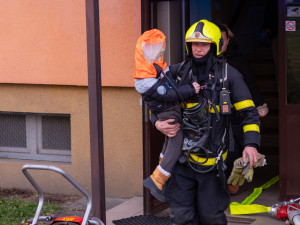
[151,20,260,225]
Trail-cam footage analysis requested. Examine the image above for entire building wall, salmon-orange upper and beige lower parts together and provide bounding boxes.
[0,0,143,198]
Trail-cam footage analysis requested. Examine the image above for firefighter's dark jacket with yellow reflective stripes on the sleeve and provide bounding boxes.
[166,57,260,152]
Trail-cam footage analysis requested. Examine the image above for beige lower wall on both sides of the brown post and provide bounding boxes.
[0,84,143,198]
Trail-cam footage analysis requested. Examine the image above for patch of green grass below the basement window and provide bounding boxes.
[0,197,62,225]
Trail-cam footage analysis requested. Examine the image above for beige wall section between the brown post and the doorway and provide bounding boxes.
[103,88,143,198]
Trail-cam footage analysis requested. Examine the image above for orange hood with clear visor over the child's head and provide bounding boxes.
[133,29,167,79]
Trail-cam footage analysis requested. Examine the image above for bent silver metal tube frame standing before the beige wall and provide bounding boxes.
[22,165,92,225]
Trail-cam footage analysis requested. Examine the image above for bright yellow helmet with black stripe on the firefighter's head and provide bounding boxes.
[185,20,223,55]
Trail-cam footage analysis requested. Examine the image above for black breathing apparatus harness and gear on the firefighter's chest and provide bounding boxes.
[178,61,231,177]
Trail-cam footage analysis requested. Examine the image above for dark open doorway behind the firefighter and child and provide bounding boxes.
[142,0,279,214]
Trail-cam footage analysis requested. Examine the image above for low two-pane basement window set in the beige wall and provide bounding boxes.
[0,112,71,162]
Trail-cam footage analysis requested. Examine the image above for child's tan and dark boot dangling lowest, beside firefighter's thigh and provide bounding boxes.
[143,167,171,202]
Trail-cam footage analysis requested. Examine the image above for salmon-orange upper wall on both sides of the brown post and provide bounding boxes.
[0,0,141,87]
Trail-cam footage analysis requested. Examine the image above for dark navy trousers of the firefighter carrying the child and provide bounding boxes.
[166,163,230,225]
